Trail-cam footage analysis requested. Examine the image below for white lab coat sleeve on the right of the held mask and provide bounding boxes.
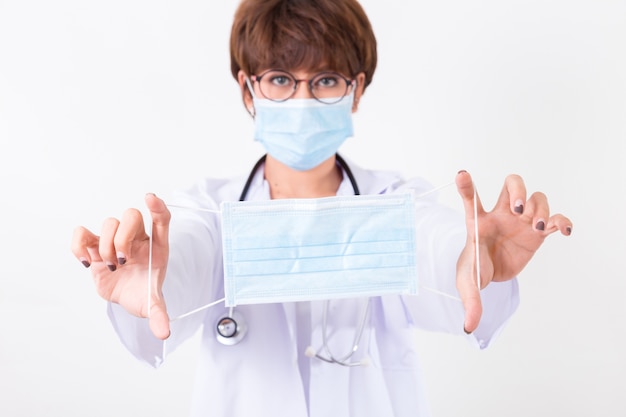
[404,192,519,349]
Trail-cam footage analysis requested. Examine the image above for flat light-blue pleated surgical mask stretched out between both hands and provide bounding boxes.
[221,194,418,306]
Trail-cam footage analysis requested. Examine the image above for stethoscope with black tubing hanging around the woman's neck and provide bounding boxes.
[216,154,370,366]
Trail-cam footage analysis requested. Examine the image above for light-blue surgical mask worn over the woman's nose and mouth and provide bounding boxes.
[248,79,354,171]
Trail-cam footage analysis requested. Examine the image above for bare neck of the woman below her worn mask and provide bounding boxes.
[265,155,343,199]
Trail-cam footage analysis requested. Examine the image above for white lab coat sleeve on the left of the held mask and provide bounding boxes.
[108,187,223,367]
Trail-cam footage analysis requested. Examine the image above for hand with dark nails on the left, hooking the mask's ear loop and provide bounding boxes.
[72,194,171,340]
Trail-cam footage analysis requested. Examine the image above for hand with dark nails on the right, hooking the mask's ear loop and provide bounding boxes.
[456,171,572,333]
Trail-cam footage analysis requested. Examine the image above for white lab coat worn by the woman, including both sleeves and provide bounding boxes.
[109,157,519,417]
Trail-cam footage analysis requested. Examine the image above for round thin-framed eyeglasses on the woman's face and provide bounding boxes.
[250,69,356,104]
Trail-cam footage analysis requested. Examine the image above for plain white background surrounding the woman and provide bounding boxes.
[0,0,626,417]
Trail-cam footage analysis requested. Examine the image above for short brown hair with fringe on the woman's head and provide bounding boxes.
[230,0,377,87]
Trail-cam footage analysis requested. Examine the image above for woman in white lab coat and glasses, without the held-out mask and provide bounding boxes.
[72,0,572,417]
